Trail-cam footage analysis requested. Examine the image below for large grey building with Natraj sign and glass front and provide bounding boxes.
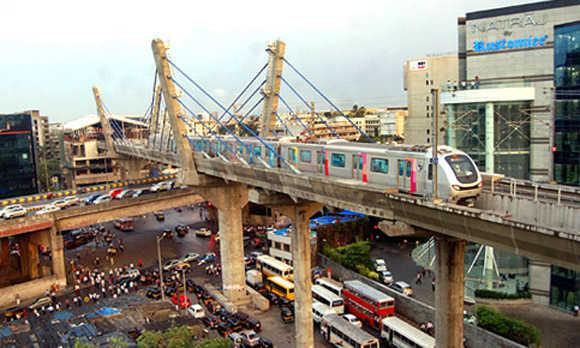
[441,0,580,184]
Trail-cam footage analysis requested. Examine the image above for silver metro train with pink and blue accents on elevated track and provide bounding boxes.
[190,137,482,205]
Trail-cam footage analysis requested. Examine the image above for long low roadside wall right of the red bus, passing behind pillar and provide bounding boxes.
[318,254,524,348]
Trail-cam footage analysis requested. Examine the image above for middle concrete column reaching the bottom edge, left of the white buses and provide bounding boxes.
[277,203,322,348]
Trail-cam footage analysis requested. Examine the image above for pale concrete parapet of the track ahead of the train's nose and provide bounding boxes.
[476,192,580,231]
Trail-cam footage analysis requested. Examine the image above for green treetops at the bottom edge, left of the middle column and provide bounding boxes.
[137,326,225,348]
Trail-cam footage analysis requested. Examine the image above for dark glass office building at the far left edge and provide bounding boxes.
[0,113,38,198]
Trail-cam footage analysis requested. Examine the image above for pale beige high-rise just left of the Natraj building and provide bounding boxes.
[403,54,458,144]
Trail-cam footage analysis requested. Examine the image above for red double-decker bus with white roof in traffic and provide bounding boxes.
[342,280,395,330]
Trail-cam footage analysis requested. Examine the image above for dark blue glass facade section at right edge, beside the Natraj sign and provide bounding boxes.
[554,22,580,186]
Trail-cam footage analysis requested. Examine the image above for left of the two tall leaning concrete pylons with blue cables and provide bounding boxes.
[151,39,200,186]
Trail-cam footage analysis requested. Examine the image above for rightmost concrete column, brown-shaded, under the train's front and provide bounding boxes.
[435,237,465,348]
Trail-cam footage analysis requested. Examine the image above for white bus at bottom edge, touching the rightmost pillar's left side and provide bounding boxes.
[381,316,435,348]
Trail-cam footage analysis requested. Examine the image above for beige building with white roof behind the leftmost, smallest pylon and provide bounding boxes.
[64,115,148,187]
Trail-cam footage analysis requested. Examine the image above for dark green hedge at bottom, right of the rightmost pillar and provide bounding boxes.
[475,305,540,346]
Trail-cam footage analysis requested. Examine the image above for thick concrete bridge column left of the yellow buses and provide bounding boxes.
[206,185,249,304]
